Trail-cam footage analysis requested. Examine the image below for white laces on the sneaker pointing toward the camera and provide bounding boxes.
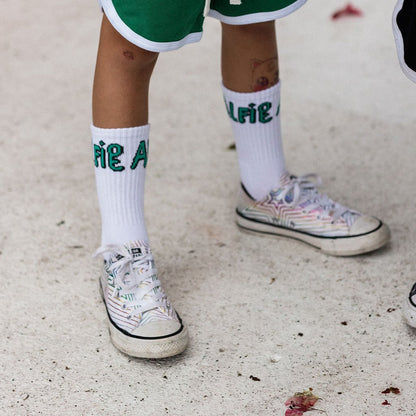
[94,245,167,318]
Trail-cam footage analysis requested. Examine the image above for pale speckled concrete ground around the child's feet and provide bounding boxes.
[0,0,416,416]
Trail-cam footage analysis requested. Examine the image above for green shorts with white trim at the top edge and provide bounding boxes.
[99,0,306,52]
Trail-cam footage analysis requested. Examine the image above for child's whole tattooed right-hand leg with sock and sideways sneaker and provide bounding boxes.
[222,22,390,256]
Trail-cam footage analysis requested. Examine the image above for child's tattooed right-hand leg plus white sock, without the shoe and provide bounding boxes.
[222,21,285,199]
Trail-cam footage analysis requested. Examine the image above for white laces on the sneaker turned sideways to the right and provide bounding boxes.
[278,173,360,227]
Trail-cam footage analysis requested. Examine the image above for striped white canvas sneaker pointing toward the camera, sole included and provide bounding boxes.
[95,241,188,358]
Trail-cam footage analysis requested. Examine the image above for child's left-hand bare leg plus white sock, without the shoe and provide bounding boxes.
[92,16,158,245]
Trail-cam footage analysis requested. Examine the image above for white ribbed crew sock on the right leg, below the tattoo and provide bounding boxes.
[223,82,286,200]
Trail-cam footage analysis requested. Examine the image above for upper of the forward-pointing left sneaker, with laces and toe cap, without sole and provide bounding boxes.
[95,241,181,337]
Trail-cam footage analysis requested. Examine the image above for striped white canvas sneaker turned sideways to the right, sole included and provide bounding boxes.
[236,173,390,256]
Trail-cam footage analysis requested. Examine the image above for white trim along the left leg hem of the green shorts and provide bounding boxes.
[99,0,202,52]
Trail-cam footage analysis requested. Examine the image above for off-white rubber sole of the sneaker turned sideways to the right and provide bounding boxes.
[236,212,390,256]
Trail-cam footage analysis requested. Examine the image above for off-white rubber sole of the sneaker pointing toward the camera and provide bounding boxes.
[99,279,189,359]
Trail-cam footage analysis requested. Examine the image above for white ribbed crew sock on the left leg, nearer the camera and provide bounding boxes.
[91,125,150,246]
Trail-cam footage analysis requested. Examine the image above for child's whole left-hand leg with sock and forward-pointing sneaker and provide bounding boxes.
[91,17,188,358]
